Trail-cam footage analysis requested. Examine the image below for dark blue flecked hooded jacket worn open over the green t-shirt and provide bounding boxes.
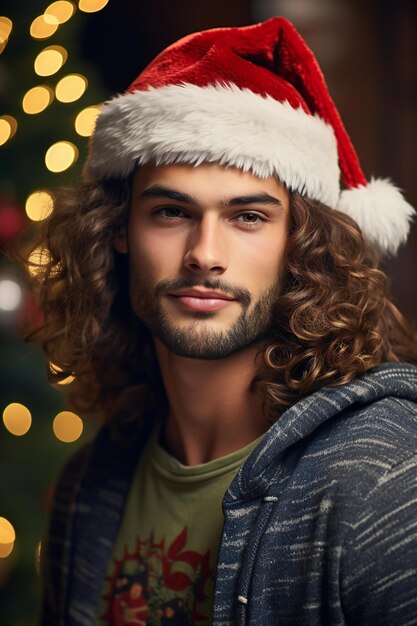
[41,363,417,626]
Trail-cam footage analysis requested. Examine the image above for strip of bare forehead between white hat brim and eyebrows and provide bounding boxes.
[132,163,288,204]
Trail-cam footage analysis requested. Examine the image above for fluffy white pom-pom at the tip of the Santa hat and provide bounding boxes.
[335,178,415,254]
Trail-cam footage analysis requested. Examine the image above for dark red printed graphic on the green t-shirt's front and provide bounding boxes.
[101,527,213,626]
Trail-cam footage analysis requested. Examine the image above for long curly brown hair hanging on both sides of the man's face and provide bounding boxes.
[26,179,417,421]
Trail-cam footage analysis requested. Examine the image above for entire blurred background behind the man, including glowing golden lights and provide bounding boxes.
[0,0,417,626]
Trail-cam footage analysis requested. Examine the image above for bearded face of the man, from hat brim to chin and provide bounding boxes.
[122,164,289,359]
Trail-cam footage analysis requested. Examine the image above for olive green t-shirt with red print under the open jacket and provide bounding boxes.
[96,431,261,626]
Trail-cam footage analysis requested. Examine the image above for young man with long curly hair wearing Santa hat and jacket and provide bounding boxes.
[37,18,417,626]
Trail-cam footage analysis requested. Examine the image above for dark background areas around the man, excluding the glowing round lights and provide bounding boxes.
[0,0,417,626]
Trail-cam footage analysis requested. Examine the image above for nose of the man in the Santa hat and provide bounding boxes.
[184,216,227,275]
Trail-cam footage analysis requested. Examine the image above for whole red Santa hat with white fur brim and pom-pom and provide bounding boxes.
[86,17,414,253]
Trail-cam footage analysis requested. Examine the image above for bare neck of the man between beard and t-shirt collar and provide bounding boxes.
[155,340,268,465]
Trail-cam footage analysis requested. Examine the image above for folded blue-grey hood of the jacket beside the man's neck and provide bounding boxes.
[224,363,417,503]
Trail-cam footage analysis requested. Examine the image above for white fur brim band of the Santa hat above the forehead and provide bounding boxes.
[86,83,340,207]
